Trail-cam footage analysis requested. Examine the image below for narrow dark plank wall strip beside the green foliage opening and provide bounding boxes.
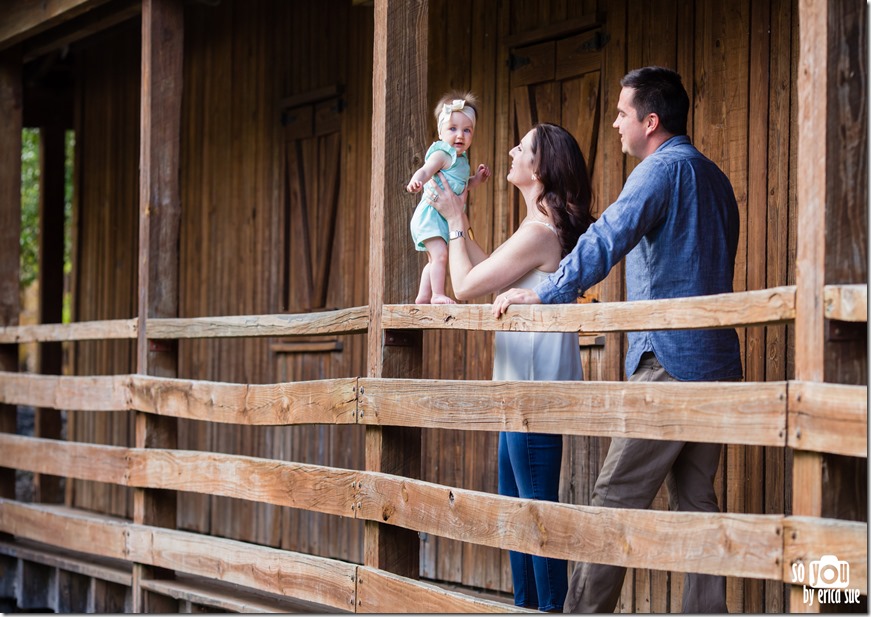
[67,21,141,518]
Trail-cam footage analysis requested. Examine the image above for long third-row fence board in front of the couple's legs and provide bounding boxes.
[358,472,783,578]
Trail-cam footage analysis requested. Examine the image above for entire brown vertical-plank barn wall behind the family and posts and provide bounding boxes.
[64,0,797,612]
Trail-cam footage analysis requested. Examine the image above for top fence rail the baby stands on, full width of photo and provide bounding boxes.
[0,285,868,344]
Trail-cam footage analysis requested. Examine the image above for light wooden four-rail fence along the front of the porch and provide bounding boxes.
[0,285,868,613]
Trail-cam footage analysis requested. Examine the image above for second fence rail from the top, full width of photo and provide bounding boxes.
[0,372,868,457]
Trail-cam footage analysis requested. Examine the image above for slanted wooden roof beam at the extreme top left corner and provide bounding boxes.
[0,0,107,51]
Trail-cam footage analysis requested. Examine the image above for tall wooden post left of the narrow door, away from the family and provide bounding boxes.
[133,0,184,612]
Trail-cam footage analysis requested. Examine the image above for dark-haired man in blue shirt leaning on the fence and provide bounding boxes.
[493,67,742,613]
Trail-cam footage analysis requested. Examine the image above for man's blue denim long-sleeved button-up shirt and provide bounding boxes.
[535,135,742,381]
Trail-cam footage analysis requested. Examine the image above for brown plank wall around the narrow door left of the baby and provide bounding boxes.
[179,1,372,561]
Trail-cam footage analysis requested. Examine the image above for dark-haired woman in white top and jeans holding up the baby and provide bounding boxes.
[428,124,594,611]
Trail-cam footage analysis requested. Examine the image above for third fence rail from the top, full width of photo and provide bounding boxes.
[0,435,867,597]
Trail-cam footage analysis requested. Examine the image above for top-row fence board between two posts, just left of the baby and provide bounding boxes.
[146,306,369,339]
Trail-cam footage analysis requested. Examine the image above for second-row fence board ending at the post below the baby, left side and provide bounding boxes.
[130,375,357,425]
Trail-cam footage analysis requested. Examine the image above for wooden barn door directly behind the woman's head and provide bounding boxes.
[509,30,605,238]
